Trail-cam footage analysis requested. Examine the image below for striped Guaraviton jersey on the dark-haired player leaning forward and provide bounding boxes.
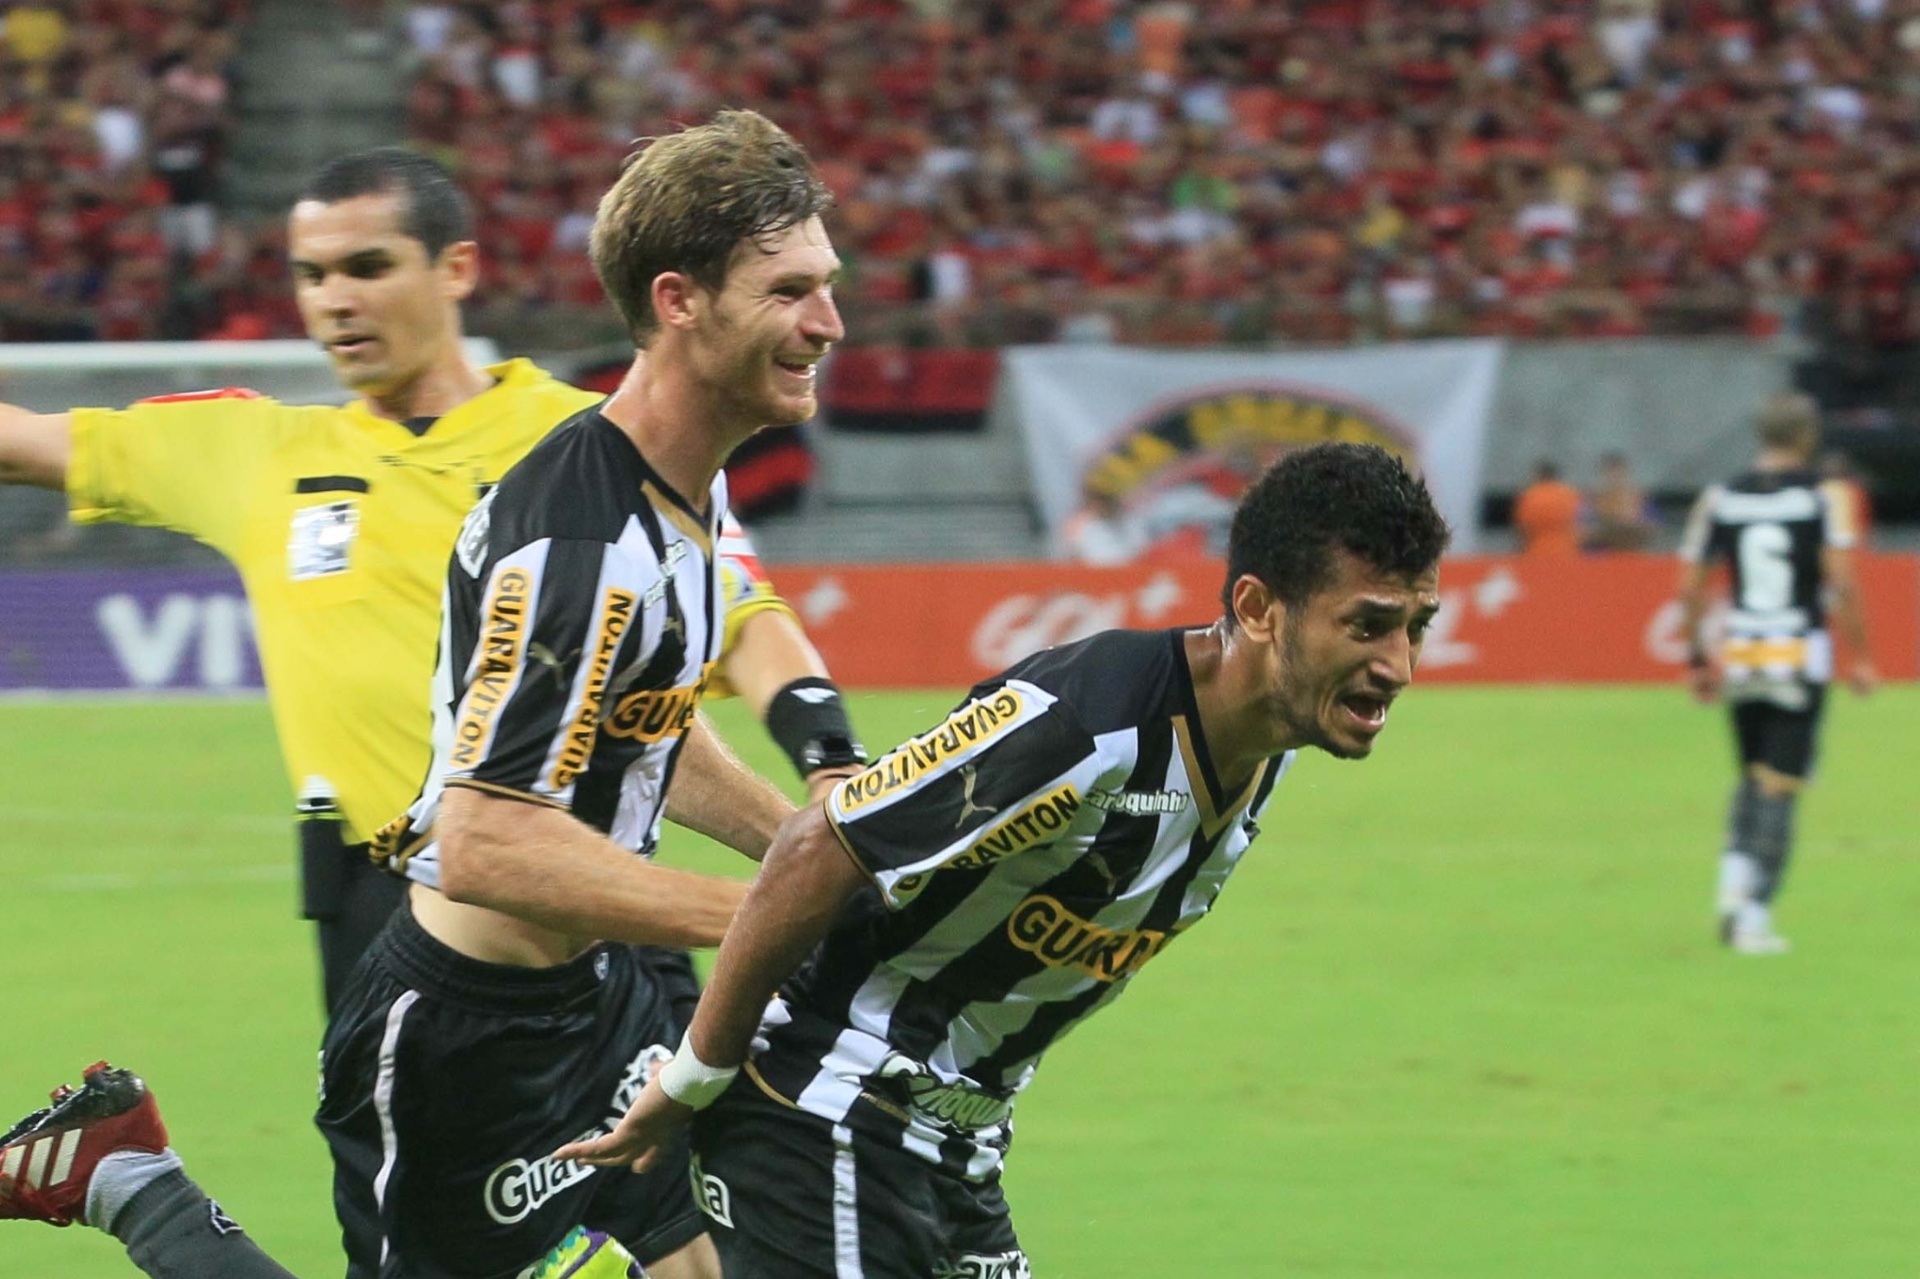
[751,630,1292,1179]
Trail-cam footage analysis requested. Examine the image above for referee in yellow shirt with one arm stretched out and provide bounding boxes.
[0,148,862,1008]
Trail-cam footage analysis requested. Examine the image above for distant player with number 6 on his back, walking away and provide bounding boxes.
[1680,394,1880,954]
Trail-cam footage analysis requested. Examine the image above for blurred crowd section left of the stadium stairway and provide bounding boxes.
[0,0,255,342]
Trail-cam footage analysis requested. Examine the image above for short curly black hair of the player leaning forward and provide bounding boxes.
[1221,444,1450,618]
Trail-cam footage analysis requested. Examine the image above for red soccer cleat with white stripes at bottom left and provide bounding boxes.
[0,1062,167,1225]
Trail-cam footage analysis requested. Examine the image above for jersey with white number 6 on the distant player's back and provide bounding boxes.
[1680,471,1857,686]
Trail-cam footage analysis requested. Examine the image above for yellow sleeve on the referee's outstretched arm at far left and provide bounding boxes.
[67,398,280,557]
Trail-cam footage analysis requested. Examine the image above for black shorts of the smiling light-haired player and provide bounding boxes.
[315,906,705,1279]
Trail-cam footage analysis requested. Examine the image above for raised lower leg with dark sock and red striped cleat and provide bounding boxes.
[0,1062,294,1279]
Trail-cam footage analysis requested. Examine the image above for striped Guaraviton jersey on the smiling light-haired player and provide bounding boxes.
[374,409,726,887]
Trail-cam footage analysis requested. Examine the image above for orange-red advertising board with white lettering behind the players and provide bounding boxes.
[774,555,1920,688]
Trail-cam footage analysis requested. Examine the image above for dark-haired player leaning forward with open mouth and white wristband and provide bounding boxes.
[559,444,1448,1279]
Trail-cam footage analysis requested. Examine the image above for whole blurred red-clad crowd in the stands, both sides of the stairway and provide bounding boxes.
[11,0,1920,348]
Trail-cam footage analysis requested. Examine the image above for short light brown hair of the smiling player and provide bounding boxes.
[589,111,833,346]
